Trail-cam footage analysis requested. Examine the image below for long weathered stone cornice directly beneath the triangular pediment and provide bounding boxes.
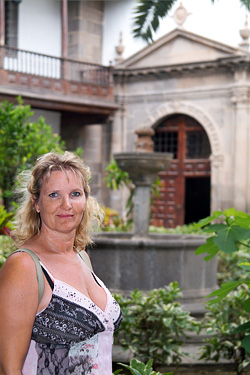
[114,54,250,82]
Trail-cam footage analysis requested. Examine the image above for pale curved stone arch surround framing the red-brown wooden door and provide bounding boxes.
[141,101,223,223]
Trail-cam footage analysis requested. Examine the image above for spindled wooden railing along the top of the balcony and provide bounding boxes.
[0,46,112,86]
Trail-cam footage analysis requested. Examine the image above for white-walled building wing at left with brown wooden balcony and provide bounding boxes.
[0,0,118,201]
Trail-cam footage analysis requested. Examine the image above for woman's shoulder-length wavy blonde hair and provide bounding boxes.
[12,151,103,251]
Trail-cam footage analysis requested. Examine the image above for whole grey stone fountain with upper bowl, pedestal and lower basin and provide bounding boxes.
[89,128,217,314]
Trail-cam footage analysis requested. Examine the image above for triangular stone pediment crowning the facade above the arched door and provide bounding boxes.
[116,28,247,69]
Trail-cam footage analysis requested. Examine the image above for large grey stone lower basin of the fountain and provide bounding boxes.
[89,232,217,310]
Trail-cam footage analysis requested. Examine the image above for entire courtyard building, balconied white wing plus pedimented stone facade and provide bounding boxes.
[0,0,250,227]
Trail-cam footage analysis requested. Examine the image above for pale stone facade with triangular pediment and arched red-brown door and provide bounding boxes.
[113,9,250,227]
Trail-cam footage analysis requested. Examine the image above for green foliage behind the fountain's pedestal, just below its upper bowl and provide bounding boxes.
[105,160,161,229]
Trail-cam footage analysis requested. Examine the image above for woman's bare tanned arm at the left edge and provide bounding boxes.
[0,253,38,375]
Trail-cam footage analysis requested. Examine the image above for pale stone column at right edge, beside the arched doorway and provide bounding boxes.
[232,82,250,211]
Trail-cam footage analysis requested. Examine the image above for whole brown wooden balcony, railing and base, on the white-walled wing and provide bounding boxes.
[0,46,117,115]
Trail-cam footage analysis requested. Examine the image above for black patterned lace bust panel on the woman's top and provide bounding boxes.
[32,295,105,345]
